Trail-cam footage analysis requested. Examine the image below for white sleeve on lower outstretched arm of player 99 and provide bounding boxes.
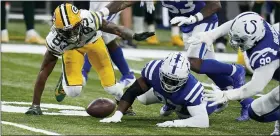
[225,60,279,100]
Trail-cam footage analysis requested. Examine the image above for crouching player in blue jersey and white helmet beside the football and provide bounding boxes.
[100,53,220,128]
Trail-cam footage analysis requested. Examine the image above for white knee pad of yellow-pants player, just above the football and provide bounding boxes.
[104,83,123,101]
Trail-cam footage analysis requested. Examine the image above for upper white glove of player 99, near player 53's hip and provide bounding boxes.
[186,32,214,47]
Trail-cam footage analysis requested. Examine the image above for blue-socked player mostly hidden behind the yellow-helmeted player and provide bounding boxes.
[82,1,136,88]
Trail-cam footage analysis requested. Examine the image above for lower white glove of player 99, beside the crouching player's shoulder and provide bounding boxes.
[203,84,229,107]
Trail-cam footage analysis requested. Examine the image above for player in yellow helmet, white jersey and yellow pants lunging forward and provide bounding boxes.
[26,3,154,115]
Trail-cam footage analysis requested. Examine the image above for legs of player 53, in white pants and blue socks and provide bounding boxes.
[186,22,253,121]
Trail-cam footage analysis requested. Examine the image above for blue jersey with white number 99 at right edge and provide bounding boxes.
[246,22,280,81]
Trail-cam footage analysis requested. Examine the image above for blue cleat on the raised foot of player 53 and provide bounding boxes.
[231,64,246,89]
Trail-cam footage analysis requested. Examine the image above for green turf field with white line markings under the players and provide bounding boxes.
[1,20,278,135]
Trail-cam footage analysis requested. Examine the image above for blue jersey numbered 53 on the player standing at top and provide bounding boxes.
[161,0,218,33]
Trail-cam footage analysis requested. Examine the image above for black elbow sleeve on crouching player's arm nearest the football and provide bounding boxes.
[121,80,145,104]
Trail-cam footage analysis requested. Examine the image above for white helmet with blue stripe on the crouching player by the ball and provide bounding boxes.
[159,52,190,93]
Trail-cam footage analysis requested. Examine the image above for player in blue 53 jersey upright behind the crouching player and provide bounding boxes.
[96,0,253,121]
